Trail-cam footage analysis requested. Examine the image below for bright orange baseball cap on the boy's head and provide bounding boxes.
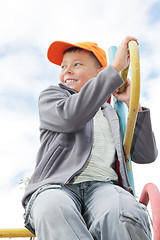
[47,41,107,67]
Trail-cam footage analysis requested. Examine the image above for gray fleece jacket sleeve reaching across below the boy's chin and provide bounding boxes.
[39,65,123,132]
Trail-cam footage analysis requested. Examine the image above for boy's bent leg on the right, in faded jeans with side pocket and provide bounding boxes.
[84,183,151,240]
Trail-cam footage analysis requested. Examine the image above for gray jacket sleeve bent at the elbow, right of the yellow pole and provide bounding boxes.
[131,108,158,164]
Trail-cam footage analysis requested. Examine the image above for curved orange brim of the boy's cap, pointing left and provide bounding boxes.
[47,41,80,65]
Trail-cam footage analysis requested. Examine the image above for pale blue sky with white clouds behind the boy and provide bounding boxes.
[0,0,160,232]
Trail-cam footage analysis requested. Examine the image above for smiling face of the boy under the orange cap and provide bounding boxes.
[60,50,99,92]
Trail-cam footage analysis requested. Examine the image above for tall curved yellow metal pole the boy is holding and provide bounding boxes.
[123,41,140,169]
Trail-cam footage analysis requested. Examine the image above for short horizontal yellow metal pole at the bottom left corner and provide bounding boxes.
[0,228,35,238]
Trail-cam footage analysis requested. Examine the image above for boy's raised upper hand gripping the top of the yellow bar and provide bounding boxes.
[112,36,138,72]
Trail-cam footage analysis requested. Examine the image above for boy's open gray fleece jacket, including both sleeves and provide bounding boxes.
[22,65,157,206]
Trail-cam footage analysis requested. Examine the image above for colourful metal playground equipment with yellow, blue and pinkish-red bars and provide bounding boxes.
[0,41,160,240]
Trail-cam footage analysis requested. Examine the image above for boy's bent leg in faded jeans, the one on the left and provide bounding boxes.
[30,187,93,240]
